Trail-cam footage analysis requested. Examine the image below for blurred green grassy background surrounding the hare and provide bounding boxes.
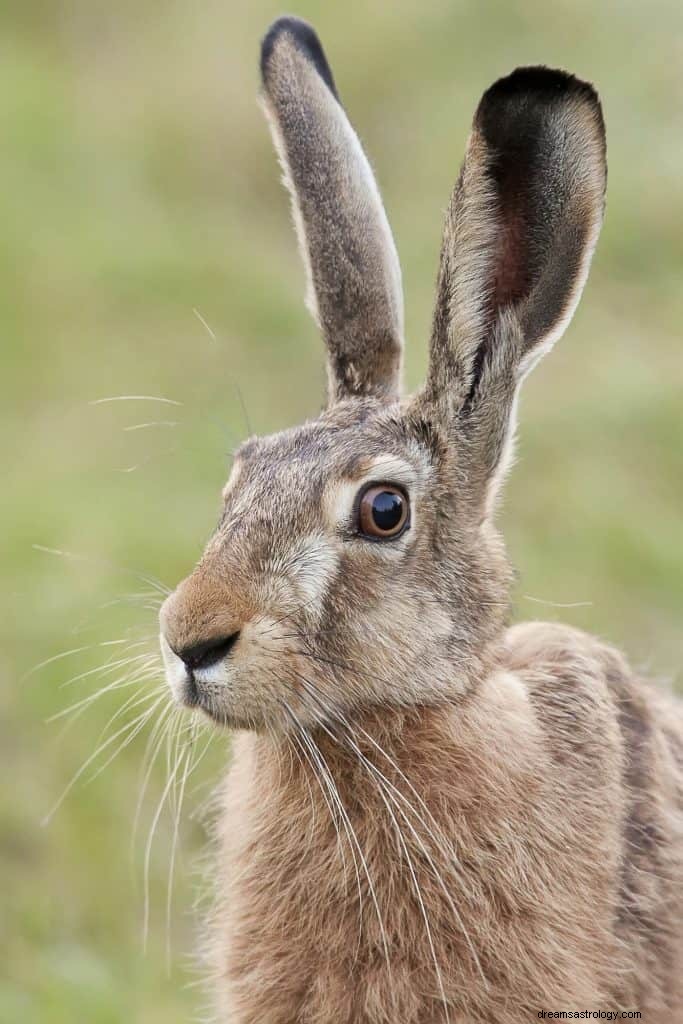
[0,0,683,1024]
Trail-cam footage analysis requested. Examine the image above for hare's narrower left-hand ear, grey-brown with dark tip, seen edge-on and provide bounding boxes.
[261,17,403,401]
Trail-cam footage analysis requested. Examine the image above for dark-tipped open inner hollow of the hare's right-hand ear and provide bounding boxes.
[474,68,605,360]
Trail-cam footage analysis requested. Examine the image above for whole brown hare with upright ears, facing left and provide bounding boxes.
[161,17,683,1024]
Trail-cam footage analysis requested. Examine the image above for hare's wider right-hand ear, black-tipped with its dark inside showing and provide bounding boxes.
[419,68,606,499]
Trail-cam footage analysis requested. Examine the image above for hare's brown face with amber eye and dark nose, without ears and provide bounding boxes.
[161,401,505,729]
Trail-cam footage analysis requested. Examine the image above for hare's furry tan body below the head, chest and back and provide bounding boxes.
[214,624,683,1024]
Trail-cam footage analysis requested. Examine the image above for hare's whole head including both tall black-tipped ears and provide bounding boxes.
[161,18,605,729]
